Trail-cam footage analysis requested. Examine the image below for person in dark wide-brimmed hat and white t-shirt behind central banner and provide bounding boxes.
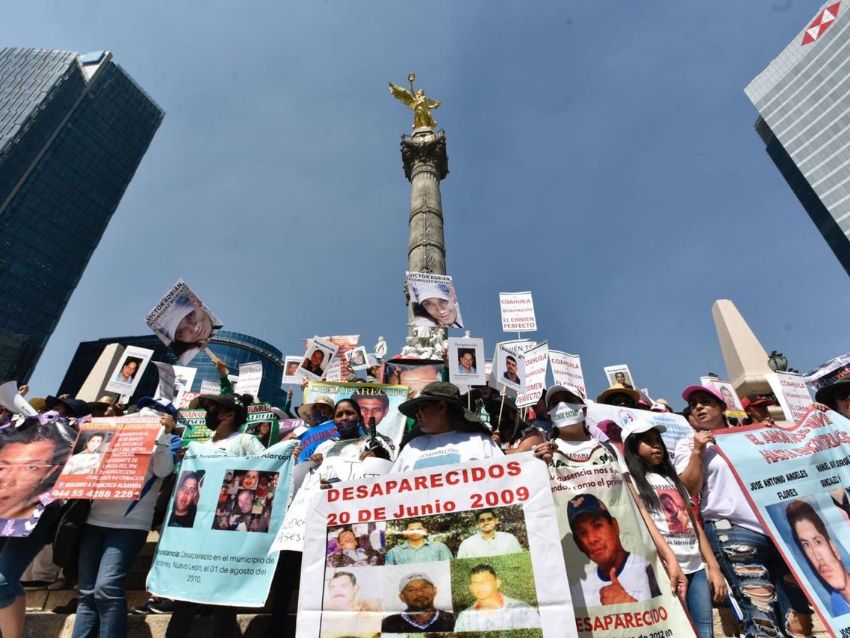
[391,381,501,472]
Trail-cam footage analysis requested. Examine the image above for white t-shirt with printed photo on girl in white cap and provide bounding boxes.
[630,472,704,574]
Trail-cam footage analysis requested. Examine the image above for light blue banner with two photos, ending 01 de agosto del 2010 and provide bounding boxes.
[147,441,295,607]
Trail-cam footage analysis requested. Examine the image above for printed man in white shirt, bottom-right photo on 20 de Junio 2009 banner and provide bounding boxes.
[455,563,540,631]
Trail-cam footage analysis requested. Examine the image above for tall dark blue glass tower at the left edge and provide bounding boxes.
[0,48,163,382]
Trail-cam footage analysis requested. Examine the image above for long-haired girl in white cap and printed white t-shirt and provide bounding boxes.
[623,420,728,638]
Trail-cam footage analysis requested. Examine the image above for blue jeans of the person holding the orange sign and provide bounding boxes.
[71,524,148,638]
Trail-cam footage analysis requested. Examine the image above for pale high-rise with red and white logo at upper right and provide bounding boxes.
[745,0,850,274]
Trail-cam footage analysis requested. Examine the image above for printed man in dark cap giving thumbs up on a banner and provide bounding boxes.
[567,494,661,607]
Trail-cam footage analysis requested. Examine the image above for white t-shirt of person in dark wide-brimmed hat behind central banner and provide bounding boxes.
[390,432,502,473]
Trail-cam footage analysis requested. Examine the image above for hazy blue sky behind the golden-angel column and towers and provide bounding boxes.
[8,0,850,405]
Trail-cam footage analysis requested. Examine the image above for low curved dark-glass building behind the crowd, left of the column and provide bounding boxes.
[57,330,286,406]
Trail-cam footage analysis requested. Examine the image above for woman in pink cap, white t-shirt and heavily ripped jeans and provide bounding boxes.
[673,385,812,637]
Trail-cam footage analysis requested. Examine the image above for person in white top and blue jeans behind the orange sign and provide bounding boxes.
[72,416,175,638]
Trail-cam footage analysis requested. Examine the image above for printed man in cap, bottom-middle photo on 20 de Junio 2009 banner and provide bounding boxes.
[381,572,455,634]
